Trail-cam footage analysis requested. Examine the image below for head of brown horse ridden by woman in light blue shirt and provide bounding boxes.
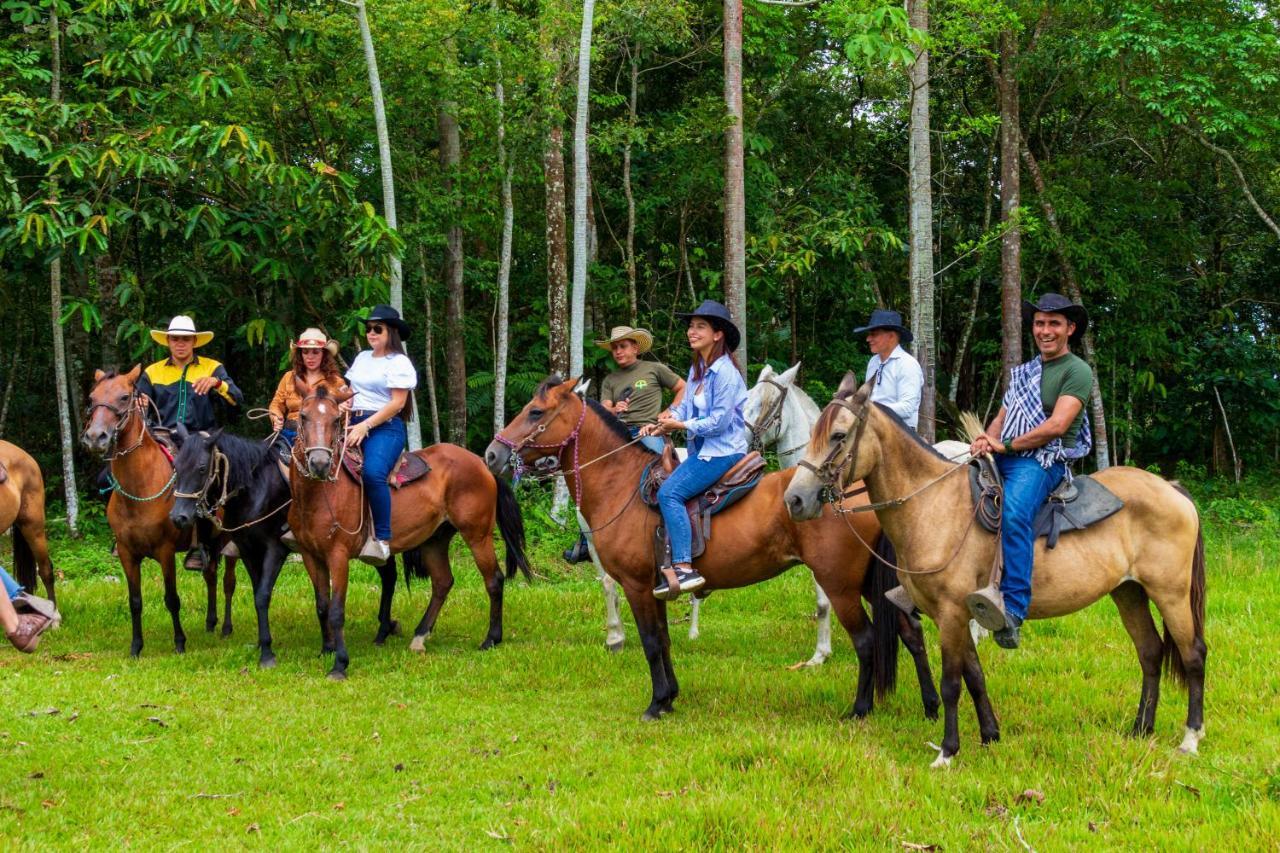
[484,374,586,475]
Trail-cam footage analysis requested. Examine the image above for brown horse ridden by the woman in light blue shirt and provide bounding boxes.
[485,377,938,720]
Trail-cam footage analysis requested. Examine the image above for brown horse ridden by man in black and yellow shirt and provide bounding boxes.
[81,365,236,657]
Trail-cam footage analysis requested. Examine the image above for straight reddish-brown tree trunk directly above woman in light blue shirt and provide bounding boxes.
[724,0,748,370]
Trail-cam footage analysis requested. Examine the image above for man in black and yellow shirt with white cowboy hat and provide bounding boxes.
[137,314,244,571]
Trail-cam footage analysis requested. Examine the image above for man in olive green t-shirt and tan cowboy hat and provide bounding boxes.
[564,325,685,564]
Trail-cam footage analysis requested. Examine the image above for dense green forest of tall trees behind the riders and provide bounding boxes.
[0,0,1280,532]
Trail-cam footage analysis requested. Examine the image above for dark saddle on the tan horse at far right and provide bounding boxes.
[969,457,1124,548]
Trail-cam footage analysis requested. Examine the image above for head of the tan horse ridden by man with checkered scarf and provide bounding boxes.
[783,373,879,521]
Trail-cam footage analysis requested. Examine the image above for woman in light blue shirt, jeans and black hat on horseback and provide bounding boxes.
[640,300,748,601]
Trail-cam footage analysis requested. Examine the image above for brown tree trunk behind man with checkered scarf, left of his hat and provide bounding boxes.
[996,31,1023,388]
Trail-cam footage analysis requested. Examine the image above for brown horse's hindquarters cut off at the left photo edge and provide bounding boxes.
[0,441,56,602]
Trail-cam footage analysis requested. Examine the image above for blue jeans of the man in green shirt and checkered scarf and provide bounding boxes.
[996,453,1066,621]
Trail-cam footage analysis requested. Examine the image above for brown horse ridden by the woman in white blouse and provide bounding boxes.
[289,384,529,680]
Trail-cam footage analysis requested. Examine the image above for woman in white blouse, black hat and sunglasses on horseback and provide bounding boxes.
[347,305,417,566]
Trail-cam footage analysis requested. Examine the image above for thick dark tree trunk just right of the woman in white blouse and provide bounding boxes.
[439,101,467,447]
